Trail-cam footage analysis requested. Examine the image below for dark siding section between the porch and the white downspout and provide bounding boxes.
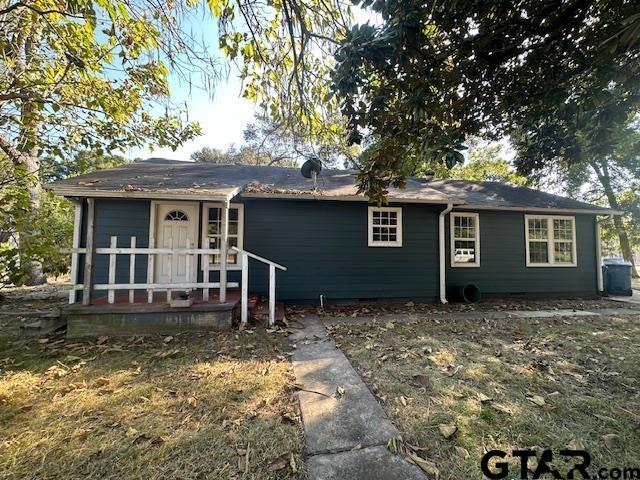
[238,199,439,301]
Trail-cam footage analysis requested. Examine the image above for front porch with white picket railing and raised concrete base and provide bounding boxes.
[62,198,286,336]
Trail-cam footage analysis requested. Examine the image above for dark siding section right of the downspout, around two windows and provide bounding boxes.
[446,210,597,296]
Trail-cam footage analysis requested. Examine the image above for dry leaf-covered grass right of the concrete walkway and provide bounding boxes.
[331,315,640,480]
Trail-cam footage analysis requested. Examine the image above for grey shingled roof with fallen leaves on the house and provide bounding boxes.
[46,158,613,214]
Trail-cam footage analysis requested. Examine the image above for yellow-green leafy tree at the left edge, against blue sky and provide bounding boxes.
[0,0,218,284]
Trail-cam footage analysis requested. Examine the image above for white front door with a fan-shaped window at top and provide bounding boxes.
[155,203,198,284]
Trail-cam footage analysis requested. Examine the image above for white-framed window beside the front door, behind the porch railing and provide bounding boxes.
[202,204,244,270]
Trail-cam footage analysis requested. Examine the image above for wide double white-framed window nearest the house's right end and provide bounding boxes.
[525,215,577,267]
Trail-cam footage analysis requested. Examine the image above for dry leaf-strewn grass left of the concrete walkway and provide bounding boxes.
[0,324,305,480]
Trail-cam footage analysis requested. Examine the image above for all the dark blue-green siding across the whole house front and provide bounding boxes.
[79,199,597,301]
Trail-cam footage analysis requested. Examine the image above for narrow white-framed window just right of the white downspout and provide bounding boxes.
[451,212,480,267]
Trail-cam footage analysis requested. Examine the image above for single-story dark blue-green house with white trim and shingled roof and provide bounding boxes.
[47,158,616,334]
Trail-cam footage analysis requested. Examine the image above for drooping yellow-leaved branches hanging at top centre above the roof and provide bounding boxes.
[215,0,351,171]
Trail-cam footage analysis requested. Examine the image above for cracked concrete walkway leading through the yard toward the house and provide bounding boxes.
[291,317,426,480]
